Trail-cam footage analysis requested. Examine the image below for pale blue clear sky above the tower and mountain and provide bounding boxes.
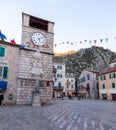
[0,0,116,53]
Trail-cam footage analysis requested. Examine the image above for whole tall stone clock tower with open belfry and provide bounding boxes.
[17,13,54,104]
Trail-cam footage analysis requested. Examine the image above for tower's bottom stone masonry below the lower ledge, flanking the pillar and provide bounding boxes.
[17,79,53,105]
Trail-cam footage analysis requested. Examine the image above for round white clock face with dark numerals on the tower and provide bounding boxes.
[32,32,46,46]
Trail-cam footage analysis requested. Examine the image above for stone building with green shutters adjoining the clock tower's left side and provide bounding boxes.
[0,41,20,104]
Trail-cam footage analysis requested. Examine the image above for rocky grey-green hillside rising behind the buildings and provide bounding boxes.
[53,46,116,78]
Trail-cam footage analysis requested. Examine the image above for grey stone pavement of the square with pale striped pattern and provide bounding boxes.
[0,99,116,130]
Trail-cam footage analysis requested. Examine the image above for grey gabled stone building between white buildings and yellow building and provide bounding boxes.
[78,70,99,99]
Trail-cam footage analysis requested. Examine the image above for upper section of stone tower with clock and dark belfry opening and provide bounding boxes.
[21,13,54,53]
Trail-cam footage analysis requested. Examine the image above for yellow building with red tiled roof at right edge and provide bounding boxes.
[99,60,116,101]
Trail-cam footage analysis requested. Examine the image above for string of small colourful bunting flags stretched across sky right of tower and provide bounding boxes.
[54,37,116,47]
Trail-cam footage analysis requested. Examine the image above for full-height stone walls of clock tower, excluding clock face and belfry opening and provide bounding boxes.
[17,13,54,104]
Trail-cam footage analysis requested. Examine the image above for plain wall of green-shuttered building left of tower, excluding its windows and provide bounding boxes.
[0,42,19,104]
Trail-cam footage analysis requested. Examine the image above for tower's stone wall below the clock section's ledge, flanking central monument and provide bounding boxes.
[17,49,53,105]
